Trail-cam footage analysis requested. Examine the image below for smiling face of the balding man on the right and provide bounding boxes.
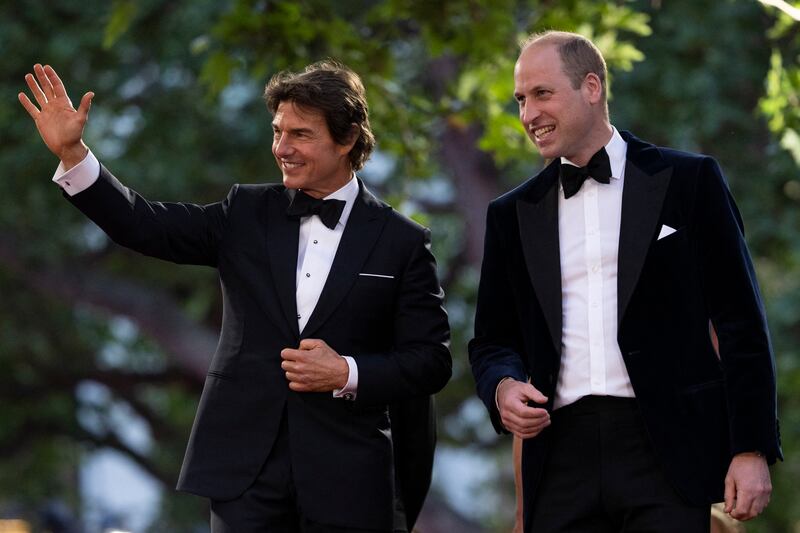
[514,44,602,165]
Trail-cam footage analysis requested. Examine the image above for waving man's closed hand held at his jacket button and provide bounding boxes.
[281,339,350,392]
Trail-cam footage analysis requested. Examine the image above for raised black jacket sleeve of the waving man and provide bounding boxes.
[65,166,238,266]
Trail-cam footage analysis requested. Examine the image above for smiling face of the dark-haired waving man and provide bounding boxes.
[272,100,353,198]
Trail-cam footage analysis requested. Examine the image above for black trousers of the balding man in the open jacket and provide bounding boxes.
[525,396,711,533]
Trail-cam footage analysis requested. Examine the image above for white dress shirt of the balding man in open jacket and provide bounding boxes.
[553,128,634,409]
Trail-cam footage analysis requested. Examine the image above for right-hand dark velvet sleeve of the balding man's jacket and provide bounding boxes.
[697,158,783,463]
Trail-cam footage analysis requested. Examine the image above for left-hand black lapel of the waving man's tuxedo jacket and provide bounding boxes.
[267,189,300,338]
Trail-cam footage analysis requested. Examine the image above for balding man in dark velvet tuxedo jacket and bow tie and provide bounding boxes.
[469,32,781,533]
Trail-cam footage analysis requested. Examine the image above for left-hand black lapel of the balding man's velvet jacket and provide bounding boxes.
[517,164,562,354]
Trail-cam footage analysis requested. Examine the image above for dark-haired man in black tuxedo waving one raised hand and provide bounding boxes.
[20,62,451,533]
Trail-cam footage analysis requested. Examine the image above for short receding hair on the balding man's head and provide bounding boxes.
[520,30,608,101]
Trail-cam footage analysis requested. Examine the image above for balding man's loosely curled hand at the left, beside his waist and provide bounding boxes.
[497,379,550,439]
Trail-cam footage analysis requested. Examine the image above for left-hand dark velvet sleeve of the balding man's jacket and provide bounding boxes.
[469,204,527,433]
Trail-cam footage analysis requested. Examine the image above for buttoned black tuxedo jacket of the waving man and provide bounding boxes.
[70,168,451,529]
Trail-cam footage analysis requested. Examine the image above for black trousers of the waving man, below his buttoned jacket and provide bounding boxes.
[211,411,405,533]
